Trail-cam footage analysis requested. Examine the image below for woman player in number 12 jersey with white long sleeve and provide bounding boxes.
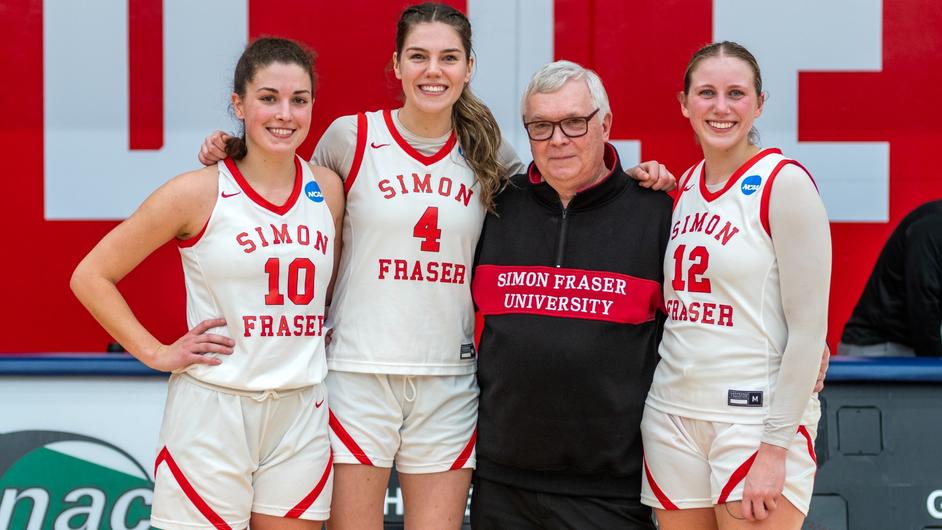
[642,42,831,529]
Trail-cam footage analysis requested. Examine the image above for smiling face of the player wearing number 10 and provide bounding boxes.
[232,62,313,154]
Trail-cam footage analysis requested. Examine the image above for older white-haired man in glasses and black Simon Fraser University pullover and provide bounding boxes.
[471,61,671,529]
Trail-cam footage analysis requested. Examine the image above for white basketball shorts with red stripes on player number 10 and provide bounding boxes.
[151,374,333,530]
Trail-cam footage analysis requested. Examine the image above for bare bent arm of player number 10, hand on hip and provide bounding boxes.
[70,168,233,371]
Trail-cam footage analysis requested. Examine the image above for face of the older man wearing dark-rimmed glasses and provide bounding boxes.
[523,79,612,204]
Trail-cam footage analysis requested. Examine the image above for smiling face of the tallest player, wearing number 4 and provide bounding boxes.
[393,22,473,120]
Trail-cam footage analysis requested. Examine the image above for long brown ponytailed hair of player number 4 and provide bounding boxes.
[396,2,507,212]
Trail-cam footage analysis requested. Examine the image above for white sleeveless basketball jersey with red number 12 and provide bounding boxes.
[647,149,818,424]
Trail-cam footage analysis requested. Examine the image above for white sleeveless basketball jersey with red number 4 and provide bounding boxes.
[327,110,484,375]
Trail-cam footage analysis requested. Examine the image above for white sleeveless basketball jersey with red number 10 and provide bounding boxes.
[179,155,334,391]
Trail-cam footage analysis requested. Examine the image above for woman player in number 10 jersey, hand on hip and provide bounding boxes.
[71,38,344,530]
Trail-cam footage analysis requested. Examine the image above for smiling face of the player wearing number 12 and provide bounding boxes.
[680,55,763,151]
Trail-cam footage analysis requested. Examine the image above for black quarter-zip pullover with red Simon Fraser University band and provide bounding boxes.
[472,145,671,498]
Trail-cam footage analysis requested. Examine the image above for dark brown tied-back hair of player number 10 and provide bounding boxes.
[226,37,317,160]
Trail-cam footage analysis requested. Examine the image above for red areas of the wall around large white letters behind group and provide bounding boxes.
[0,0,942,352]
